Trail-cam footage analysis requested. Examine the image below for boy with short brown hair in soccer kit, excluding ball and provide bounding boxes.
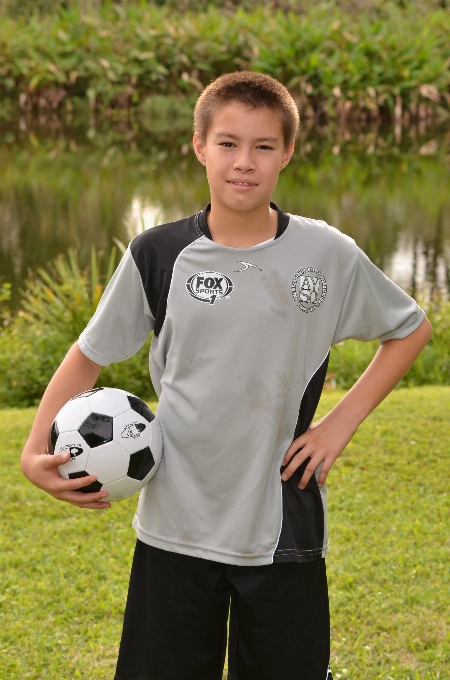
[22,72,430,680]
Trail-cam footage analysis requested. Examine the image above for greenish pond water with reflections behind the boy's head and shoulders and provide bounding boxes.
[0,119,450,307]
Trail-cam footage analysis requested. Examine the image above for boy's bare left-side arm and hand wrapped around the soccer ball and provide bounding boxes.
[20,343,110,510]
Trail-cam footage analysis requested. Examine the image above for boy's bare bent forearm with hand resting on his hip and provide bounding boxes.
[281,319,431,489]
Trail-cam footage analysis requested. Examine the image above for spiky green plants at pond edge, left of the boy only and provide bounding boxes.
[0,248,155,406]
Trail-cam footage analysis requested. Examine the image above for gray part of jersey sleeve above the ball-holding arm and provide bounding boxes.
[78,248,154,366]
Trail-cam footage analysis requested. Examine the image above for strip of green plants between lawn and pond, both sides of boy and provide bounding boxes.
[0,241,450,406]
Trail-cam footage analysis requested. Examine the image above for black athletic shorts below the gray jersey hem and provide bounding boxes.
[115,540,332,680]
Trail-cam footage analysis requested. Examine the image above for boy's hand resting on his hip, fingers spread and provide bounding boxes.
[281,413,357,489]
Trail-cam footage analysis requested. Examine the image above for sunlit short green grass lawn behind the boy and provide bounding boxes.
[0,387,450,680]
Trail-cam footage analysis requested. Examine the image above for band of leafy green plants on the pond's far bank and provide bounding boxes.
[0,0,450,120]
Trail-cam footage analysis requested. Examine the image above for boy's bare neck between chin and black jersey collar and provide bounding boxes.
[206,196,278,248]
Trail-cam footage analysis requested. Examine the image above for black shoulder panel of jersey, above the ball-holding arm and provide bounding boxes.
[130,215,203,335]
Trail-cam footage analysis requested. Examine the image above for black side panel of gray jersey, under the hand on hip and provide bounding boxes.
[273,354,330,562]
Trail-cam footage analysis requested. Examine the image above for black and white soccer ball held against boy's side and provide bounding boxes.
[49,387,163,501]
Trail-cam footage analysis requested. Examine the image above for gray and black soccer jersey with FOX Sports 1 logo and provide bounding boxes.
[79,206,424,565]
